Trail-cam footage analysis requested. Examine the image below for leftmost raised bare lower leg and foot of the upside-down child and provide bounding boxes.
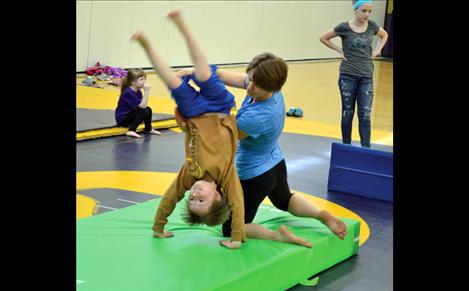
[131,31,182,89]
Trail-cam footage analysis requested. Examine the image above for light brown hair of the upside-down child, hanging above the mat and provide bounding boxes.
[182,186,231,226]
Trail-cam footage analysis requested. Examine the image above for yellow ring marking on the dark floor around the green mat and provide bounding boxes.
[77,171,370,245]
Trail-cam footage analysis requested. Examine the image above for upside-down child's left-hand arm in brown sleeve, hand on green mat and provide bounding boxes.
[152,164,194,238]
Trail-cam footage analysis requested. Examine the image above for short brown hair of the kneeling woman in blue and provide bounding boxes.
[246,53,288,92]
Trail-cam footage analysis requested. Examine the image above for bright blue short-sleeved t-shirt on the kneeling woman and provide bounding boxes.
[235,91,285,180]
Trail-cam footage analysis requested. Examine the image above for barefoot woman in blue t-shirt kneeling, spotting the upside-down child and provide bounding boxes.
[181,53,347,247]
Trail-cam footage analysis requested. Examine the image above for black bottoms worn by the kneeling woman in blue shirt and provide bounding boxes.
[223,160,293,237]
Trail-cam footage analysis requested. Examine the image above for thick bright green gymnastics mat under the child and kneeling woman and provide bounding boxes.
[76,194,360,290]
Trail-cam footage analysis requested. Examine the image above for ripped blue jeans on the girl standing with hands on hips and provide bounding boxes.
[339,74,373,148]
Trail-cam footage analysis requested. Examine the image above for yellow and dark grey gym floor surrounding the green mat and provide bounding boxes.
[77,60,393,290]
